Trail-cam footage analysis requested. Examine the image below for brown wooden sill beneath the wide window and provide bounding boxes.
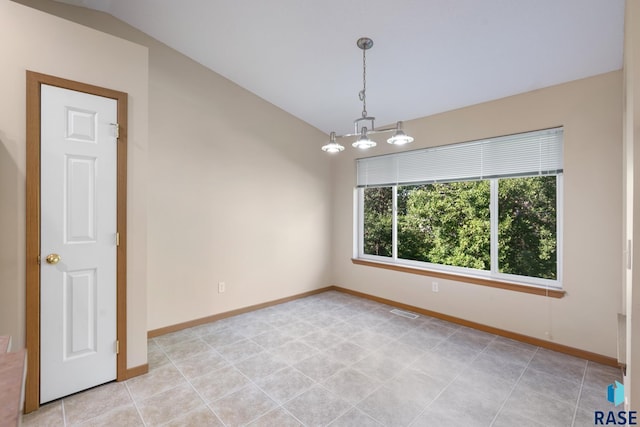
[351,258,566,298]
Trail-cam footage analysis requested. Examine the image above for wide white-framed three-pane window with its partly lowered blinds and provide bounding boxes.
[357,128,563,288]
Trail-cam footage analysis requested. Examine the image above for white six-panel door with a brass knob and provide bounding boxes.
[40,85,117,403]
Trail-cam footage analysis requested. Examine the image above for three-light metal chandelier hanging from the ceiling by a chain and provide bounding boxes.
[322,37,413,153]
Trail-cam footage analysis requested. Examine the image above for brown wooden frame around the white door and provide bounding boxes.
[24,71,128,413]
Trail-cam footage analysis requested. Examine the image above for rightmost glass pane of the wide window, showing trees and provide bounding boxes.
[498,176,557,279]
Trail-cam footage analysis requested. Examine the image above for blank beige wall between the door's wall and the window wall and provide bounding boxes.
[11,0,331,330]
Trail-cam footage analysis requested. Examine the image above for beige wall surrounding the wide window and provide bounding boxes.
[333,71,622,357]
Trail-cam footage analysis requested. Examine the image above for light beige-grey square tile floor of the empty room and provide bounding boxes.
[23,291,621,427]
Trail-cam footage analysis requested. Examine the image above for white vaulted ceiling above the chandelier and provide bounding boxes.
[55,0,624,133]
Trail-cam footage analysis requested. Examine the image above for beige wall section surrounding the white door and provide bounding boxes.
[0,0,148,367]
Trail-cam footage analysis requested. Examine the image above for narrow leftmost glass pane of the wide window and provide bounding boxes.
[364,187,393,257]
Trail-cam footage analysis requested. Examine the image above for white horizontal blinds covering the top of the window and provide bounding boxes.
[356,127,563,187]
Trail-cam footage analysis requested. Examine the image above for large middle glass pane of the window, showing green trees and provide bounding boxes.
[398,181,491,270]
